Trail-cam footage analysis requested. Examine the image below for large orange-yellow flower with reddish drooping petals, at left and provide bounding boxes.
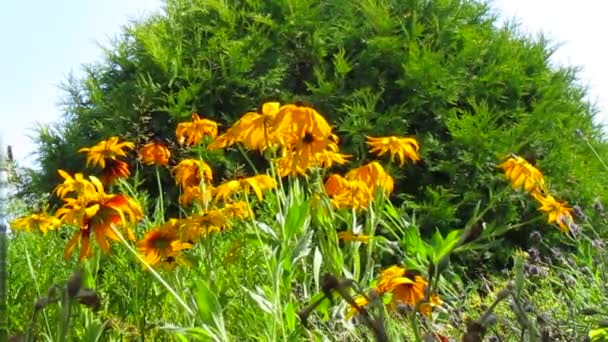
[55,177,143,260]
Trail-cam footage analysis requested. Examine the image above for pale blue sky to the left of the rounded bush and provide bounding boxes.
[0,0,162,165]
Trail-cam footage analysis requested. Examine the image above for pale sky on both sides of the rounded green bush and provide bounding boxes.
[0,0,608,166]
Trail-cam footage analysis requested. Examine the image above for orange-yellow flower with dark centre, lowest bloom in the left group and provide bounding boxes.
[137,219,192,266]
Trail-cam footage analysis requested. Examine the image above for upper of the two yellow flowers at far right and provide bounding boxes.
[498,155,545,193]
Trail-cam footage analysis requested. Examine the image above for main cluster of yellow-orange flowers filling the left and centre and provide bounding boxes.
[13,102,420,268]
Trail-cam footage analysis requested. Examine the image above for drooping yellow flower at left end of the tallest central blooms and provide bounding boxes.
[209,102,279,151]
